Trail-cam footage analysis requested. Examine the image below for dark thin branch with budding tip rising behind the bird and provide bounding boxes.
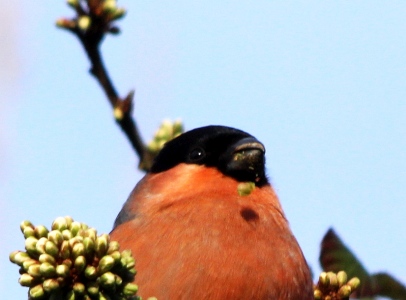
[57,0,153,171]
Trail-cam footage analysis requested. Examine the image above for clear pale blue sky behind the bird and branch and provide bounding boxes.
[0,0,406,299]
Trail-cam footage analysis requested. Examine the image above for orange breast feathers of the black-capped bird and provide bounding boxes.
[111,165,313,300]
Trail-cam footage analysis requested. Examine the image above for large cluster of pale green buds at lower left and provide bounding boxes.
[10,217,139,300]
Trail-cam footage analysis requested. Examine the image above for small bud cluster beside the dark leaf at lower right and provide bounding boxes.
[314,271,360,300]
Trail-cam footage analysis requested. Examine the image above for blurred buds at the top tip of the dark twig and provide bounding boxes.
[56,0,126,33]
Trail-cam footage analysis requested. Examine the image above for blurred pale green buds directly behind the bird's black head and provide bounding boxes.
[147,120,184,154]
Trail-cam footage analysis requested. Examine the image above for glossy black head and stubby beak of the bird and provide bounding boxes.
[150,126,268,187]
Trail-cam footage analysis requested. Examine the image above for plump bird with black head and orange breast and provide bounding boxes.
[110,125,313,300]
